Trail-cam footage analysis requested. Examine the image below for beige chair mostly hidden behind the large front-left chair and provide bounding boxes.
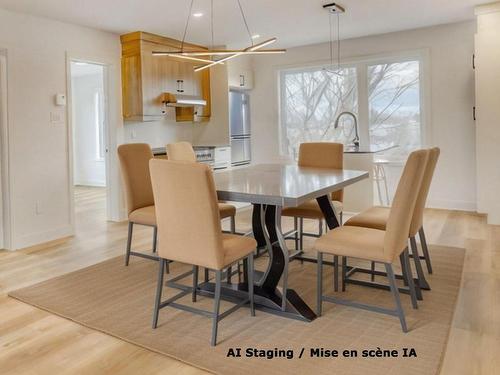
[167,142,241,283]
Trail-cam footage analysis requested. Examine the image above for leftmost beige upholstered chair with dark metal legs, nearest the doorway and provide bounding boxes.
[118,143,157,266]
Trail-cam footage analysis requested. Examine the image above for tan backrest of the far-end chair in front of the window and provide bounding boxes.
[298,142,344,202]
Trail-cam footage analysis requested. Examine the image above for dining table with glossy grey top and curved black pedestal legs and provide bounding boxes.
[171,163,369,322]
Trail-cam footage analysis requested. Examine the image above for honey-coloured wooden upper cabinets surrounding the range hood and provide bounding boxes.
[121,32,211,121]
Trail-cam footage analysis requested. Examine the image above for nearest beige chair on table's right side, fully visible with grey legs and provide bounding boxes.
[315,150,429,332]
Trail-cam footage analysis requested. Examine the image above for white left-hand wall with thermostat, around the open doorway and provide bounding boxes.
[0,10,122,249]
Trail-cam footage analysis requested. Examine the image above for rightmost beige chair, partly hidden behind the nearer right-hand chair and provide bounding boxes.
[345,147,440,282]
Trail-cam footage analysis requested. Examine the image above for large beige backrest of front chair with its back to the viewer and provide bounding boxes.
[150,159,224,270]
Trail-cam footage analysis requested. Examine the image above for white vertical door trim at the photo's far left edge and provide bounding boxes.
[0,49,13,249]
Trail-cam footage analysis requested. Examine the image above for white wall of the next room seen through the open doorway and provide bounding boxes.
[71,67,106,186]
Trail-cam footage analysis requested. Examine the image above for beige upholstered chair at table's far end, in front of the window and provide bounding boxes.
[282,142,344,253]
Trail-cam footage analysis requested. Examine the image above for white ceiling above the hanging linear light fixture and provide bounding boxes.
[0,0,488,47]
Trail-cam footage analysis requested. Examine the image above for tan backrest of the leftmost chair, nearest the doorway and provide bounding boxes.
[118,143,154,214]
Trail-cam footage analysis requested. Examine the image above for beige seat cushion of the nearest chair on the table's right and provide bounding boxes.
[314,226,393,263]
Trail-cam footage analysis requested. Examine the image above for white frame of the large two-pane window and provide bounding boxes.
[276,49,432,158]
